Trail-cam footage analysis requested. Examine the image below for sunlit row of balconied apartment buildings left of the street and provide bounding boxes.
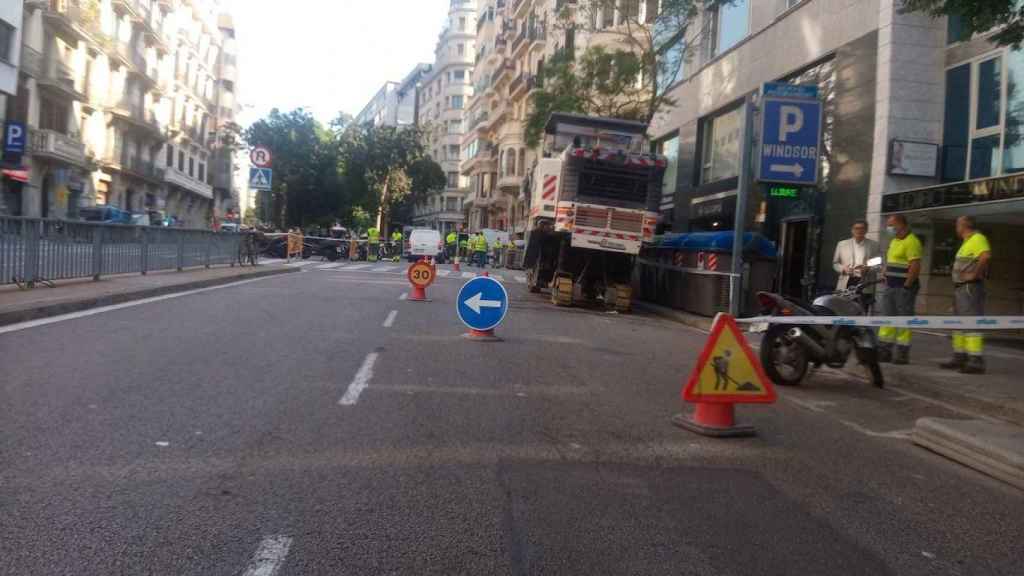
[3,0,238,228]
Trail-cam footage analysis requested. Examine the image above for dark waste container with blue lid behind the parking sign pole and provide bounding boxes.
[682,232,776,317]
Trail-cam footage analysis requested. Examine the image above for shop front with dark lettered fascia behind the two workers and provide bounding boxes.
[882,174,1024,315]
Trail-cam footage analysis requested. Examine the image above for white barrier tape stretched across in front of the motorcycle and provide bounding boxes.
[736,316,1024,331]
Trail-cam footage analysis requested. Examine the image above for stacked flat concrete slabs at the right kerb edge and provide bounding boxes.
[912,418,1024,490]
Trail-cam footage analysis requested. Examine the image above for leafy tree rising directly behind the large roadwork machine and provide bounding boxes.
[524,0,712,147]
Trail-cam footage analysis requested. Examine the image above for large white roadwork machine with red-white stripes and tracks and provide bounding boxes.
[523,113,668,312]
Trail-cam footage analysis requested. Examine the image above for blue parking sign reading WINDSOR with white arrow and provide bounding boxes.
[758,85,821,186]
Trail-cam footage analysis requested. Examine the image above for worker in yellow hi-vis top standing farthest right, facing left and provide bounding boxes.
[942,216,992,374]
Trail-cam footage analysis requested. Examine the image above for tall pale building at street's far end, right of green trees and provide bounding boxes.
[413,0,476,235]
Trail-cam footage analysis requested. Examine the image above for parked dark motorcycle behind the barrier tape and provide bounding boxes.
[752,258,885,388]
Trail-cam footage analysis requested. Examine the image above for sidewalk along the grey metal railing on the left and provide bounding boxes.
[0,264,299,326]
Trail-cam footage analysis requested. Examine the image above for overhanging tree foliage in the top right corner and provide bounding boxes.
[900,0,1024,48]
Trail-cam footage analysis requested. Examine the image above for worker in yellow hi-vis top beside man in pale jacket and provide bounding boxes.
[879,214,924,364]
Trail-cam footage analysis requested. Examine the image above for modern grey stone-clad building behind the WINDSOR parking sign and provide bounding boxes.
[651,0,1024,314]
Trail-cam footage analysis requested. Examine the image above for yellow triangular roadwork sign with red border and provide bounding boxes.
[683,314,775,404]
